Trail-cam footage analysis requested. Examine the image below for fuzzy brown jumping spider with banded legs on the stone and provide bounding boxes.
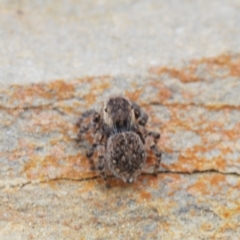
[77,96,161,186]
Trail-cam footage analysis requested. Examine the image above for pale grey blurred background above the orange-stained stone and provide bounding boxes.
[0,0,240,84]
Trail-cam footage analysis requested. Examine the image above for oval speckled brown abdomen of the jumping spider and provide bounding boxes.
[106,132,146,183]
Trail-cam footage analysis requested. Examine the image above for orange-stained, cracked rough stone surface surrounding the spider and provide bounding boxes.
[0,54,240,239]
